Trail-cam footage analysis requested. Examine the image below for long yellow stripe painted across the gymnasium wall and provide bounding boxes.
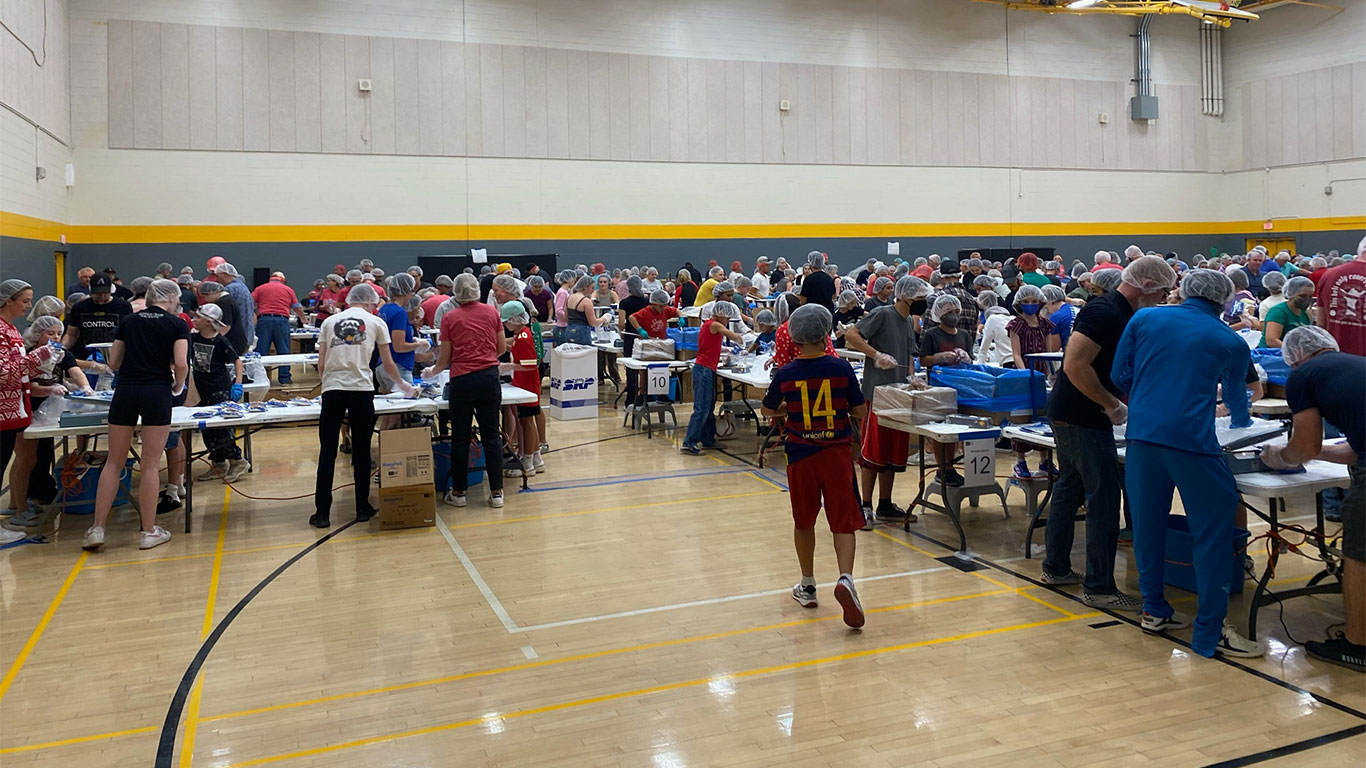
[0,212,1366,243]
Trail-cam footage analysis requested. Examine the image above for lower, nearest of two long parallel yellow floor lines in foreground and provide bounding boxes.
[228,616,1081,768]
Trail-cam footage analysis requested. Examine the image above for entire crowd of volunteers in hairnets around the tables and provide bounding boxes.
[0,239,1366,670]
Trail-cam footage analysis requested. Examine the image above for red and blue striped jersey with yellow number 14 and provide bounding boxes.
[764,355,863,462]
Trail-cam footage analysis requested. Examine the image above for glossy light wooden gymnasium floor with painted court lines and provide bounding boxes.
[0,379,1366,768]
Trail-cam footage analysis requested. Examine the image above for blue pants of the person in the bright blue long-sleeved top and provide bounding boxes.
[1124,440,1238,657]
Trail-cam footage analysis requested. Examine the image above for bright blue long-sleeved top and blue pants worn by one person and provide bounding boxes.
[1111,299,1251,656]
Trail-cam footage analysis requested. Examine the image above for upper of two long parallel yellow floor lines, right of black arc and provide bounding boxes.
[199,589,1011,723]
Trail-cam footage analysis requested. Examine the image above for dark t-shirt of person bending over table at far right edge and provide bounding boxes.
[1285,351,1366,456]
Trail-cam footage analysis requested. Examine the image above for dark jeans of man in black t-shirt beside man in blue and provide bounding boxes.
[1044,424,1123,594]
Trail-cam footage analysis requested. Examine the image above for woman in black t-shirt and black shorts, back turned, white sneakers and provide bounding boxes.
[82,280,190,551]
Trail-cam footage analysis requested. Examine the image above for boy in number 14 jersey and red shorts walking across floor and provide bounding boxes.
[764,303,866,627]
